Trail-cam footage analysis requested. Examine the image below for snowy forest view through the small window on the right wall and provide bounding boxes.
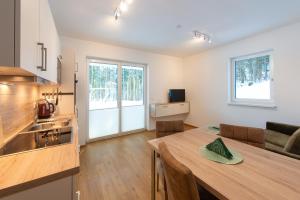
[234,55,271,100]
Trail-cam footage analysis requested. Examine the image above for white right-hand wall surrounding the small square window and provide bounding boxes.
[183,23,300,127]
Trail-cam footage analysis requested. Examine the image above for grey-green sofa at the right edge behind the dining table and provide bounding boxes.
[265,122,300,160]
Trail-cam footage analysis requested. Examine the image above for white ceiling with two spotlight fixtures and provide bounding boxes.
[49,0,300,56]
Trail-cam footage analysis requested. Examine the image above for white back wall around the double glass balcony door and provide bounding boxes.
[61,37,183,145]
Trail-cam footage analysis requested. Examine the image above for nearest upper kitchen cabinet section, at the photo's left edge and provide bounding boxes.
[0,0,39,74]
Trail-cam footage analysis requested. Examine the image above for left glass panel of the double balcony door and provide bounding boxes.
[89,62,120,140]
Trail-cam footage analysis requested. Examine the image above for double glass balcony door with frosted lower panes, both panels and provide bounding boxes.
[88,59,145,141]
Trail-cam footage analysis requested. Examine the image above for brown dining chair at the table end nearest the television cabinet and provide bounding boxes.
[156,120,184,200]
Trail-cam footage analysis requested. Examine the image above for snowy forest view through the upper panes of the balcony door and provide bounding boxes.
[89,63,144,110]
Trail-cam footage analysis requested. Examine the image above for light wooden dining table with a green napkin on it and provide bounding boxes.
[148,129,300,200]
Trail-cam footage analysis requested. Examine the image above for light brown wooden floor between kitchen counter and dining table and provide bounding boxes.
[79,127,196,200]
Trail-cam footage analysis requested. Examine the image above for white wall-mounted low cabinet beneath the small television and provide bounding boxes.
[150,102,190,118]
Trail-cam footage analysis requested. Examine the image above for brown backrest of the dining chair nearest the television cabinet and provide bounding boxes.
[156,120,184,138]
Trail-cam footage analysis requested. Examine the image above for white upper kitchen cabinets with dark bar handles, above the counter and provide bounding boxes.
[0,0,60,82]
